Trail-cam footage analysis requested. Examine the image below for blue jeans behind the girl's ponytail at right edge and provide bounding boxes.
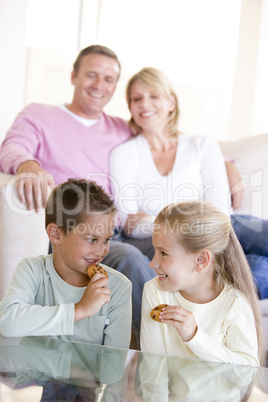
[231,215,268,299]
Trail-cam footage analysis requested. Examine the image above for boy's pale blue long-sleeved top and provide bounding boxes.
[0,255,132,348]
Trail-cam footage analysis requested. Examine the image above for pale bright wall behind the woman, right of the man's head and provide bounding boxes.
[99,0,243,138]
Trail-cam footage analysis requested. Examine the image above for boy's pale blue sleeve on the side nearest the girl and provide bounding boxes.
[104,278,132,348]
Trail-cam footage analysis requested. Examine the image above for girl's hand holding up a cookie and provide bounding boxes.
[160,306,197,342]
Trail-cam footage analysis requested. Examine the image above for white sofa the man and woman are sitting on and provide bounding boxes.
[0,134,268,350]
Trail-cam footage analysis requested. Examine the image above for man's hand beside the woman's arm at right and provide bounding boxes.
[225,162,245,210]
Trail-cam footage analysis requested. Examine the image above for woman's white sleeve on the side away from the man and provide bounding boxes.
[197,137,232,215]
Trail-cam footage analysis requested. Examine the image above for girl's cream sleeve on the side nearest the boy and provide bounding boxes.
[140,282,167,354]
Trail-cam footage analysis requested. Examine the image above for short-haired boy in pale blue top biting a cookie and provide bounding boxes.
[0,179,132,348]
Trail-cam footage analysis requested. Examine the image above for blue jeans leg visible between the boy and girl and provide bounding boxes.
[102,237,156,345]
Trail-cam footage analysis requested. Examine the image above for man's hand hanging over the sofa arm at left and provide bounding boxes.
[16,161,55,212]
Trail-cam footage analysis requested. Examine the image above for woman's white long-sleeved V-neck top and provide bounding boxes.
[110,134,231,225]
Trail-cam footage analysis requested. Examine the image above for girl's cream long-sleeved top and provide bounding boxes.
[141,278,259,366]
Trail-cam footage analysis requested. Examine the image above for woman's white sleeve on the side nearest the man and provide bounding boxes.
[110,144,142,226]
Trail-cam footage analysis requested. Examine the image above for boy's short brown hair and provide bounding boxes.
[45,179,117,234]
